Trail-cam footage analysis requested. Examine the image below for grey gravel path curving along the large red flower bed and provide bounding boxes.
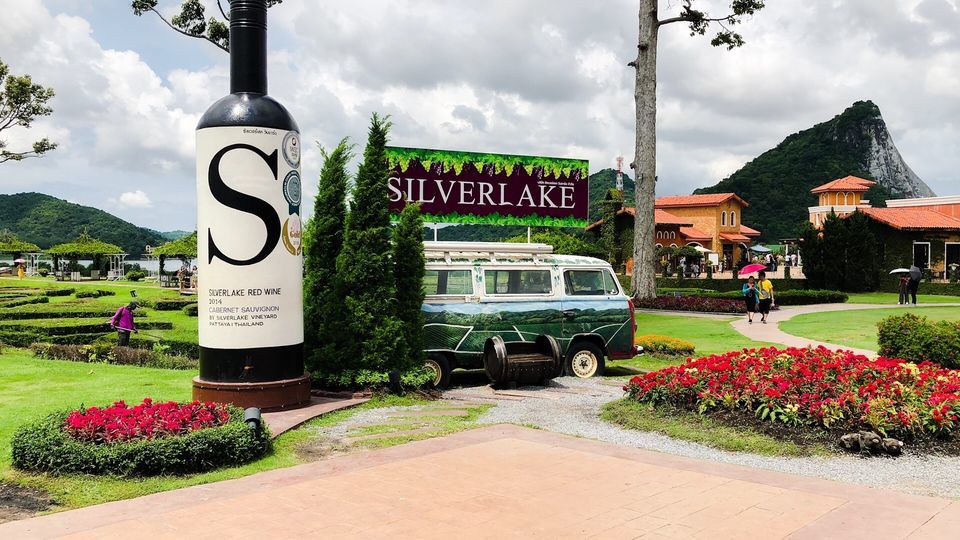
[450,377,960,498]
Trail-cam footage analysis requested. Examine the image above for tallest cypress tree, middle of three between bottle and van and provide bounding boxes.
[337,114,408,373]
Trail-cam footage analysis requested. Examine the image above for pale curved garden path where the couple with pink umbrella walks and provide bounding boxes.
[730,304,960,356]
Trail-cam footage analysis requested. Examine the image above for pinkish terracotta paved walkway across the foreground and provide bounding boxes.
[0,425,960,540]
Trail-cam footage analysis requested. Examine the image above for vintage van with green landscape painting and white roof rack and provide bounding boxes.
[423,242,636,388]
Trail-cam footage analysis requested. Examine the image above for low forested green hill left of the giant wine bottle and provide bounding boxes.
[0,193,166,256]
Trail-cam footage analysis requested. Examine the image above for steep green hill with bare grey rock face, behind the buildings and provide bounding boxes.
[695,101,933,242]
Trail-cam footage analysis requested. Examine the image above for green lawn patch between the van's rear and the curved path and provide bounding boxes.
[637,313,776,356]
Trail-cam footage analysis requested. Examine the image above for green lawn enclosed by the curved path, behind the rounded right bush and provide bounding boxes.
[780,306,960,351]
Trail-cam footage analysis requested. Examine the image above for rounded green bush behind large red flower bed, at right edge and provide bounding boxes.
[877,313,960,369]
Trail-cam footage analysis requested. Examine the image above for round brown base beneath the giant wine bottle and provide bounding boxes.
[193,373,310,411]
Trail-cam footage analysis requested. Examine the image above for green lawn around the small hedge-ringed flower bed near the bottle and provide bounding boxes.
[0,349,423,510]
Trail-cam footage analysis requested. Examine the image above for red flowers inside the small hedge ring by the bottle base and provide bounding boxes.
[64,398,230,443]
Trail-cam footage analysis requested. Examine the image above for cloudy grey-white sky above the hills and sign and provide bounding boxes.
[0,0,960,230]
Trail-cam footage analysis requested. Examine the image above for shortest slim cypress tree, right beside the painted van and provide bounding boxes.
[393,204,424,371]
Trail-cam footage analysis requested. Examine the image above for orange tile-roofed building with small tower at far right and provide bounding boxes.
[809,176,960,277]
